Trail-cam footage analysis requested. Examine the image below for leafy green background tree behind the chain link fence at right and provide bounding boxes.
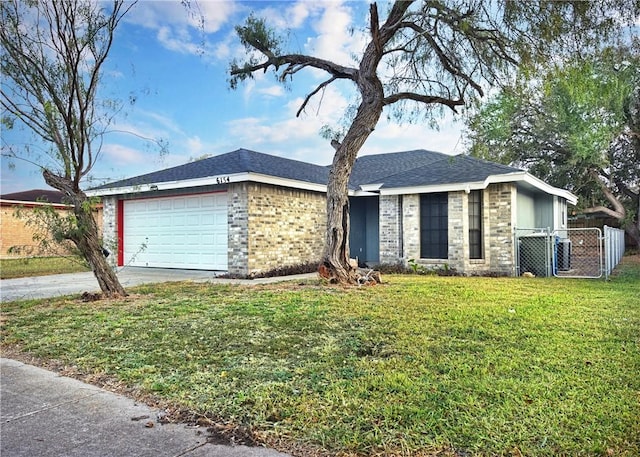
[469,42,640,246]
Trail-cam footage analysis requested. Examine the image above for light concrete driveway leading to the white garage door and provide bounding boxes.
[0,267,317,302]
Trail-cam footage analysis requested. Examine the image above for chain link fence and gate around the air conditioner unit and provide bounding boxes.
[514,228,604,278]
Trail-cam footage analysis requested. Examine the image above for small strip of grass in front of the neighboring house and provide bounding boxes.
[0,257,91,279]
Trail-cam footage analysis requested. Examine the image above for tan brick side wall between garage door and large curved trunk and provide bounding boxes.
[235,183,327,275]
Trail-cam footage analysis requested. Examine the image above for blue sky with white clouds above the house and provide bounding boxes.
[1,0,464,194]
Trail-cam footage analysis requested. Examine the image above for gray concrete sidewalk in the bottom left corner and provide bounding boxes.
[0,358,287,457]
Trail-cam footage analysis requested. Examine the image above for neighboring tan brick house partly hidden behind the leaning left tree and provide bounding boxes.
[0,189,103,257]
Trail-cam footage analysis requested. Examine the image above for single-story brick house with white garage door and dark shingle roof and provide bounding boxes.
[87,149,577,276]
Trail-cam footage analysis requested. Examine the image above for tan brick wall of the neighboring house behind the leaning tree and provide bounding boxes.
[0,204,102,258]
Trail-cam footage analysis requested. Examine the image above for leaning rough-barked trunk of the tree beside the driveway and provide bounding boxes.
[43,170,127,297]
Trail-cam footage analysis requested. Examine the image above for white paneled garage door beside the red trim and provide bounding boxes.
[123,193,228,270]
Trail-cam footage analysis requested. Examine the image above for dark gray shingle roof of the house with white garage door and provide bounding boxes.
[95,149,520,190]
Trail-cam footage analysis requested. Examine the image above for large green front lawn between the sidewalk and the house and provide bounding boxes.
[2,256,640,457]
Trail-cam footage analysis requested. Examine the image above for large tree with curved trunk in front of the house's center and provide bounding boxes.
[230,0,635,282]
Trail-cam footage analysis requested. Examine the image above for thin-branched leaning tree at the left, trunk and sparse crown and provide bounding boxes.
[0,0,135,296]
